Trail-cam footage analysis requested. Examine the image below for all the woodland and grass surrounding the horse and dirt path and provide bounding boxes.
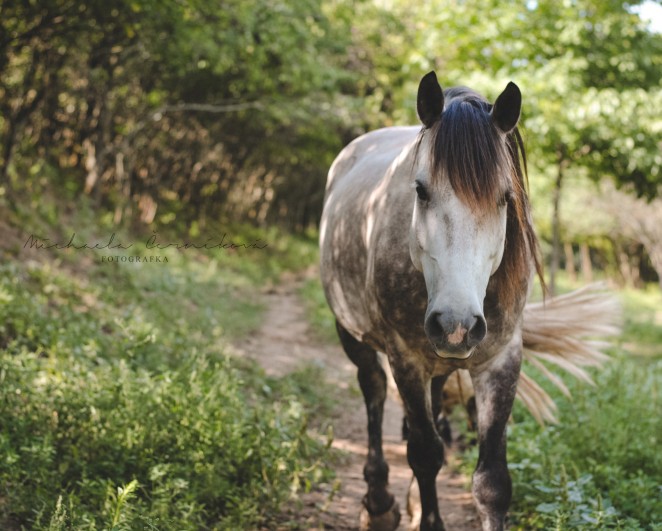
[0,0,662,531]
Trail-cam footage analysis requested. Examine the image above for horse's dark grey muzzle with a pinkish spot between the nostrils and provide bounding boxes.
[425,311,487,359]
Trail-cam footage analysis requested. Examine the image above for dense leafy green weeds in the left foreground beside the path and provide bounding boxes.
[0,353,332,529]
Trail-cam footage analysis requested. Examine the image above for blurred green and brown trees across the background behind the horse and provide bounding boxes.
[0,0,662,238]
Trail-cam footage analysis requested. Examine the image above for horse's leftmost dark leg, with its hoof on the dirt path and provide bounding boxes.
[336,322,400,531]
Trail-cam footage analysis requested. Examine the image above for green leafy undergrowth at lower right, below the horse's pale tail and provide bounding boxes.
[508,357,662,530]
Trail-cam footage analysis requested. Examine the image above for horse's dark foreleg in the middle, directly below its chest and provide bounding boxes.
[394,366,444,531]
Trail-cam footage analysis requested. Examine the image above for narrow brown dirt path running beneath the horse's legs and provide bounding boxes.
[237,279,480,531]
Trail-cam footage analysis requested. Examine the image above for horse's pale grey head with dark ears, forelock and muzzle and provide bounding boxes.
[409,72,521,358]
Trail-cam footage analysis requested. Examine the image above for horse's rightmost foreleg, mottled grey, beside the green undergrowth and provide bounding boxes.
[472,345,522,531]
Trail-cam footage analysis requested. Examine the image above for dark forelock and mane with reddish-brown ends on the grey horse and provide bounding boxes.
[416,87,544,305]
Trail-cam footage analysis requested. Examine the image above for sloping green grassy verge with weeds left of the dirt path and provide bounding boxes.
[0,208,338,530]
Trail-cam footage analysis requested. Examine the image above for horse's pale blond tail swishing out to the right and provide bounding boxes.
[517,284,621,423]
